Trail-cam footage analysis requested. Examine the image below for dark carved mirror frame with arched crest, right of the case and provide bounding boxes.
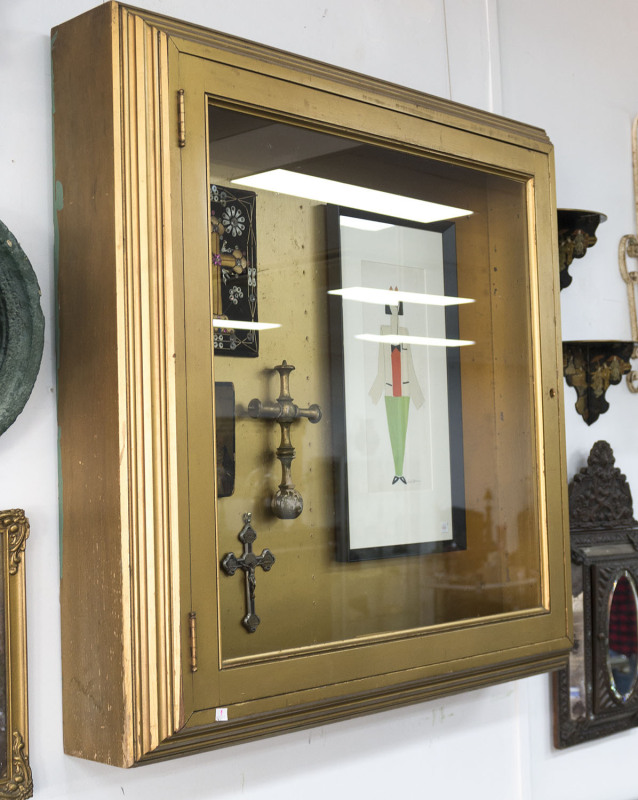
[554,441,638,748]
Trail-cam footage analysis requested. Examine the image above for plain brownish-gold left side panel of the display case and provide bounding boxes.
[52,3,131,766]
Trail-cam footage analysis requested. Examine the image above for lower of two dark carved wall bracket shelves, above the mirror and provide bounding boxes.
[563,341,634,425]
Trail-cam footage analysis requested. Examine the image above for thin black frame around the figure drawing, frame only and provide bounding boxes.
[326,205,467,562]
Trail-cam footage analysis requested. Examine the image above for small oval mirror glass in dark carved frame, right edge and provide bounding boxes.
[607,572,638,700]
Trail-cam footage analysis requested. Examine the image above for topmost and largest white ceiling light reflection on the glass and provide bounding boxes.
[231,169,472,222]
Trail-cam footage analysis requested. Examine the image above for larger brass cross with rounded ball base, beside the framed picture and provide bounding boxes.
[248,361,321,519]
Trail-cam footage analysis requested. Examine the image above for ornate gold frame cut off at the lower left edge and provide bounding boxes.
[0,509,33,800]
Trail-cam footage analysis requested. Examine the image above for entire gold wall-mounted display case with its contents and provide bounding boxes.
[52,2,571,766]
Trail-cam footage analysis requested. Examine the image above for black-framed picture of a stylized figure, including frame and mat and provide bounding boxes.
[327,206,471,561]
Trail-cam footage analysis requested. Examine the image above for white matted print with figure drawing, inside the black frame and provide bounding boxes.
[330,212,464,560]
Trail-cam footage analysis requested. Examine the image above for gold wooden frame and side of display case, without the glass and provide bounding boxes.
[52,2,571,766]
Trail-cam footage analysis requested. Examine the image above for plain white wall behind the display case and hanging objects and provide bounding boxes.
[0,0,638,800]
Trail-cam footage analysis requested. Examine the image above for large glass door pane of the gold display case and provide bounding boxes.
[209,104,542,661]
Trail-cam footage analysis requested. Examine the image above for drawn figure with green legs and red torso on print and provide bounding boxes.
[369,286,425,485]
